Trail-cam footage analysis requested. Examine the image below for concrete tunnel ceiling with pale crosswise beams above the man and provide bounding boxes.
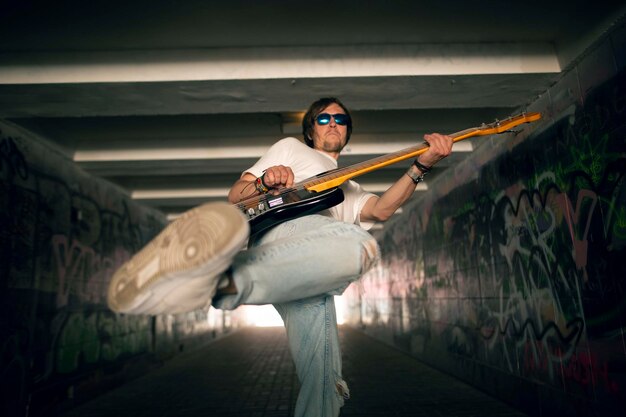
[0,0,624,226]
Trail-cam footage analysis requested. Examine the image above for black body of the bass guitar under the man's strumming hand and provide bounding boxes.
[237,187,344,235]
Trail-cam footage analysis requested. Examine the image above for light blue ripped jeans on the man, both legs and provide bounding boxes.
[213,215,379,417]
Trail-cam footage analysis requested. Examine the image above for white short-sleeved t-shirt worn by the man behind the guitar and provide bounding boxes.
[245,137,374,230]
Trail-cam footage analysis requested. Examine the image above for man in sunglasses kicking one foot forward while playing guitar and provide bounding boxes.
[109,97,452,417]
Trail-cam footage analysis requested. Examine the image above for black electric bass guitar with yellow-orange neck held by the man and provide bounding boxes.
[235,113,541,235]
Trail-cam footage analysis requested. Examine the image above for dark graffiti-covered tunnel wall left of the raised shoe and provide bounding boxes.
[0,121,240,416]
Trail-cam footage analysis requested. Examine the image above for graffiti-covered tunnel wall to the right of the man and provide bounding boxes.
[347,26,626,416]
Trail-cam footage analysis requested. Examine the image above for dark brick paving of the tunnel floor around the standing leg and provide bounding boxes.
[57,327,526,417]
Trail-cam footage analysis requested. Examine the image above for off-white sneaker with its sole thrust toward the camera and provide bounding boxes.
[107,203,250,315]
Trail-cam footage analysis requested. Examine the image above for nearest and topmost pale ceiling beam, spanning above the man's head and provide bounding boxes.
[0,42,561,85]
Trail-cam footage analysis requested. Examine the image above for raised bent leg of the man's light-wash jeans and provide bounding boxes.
[215,215,380,309]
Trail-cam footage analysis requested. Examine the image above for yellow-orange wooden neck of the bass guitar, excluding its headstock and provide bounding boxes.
[299,127,479,192]
